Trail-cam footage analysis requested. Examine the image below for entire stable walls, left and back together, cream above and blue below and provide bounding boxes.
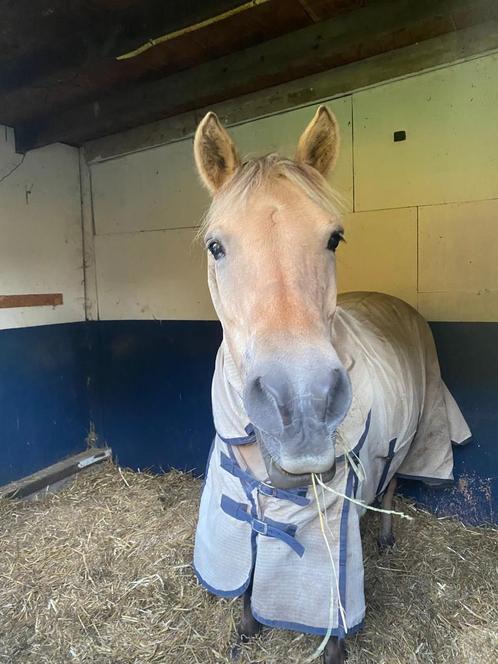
[0,55,498,522]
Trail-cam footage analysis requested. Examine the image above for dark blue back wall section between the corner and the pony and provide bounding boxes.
[98,321,221,474]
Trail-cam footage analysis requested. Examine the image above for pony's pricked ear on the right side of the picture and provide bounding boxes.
[296,106,340,176]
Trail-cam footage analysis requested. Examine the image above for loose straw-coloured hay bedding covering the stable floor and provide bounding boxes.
[0,463,498,664]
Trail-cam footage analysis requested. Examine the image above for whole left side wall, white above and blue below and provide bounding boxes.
[0,127,88,484]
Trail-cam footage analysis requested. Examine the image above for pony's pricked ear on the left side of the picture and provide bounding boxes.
[194,113,240,194]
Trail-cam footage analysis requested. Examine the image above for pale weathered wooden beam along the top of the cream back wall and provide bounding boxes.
[84,21,498,163]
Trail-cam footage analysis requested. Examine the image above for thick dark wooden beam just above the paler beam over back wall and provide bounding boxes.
[16,0,498,151]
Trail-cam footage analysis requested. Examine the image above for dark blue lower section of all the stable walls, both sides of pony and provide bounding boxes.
[0,321,498,523]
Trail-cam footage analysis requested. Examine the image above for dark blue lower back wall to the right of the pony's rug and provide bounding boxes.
[402,323,498,524]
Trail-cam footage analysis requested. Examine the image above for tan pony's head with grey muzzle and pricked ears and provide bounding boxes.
[194,106,351,488]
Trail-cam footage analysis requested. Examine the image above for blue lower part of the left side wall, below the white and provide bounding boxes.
[0,323,98,484]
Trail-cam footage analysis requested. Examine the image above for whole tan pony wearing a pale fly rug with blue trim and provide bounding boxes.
[194,106,470,664]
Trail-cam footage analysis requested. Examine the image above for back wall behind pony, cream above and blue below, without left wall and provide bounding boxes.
[83,54,498,520]
